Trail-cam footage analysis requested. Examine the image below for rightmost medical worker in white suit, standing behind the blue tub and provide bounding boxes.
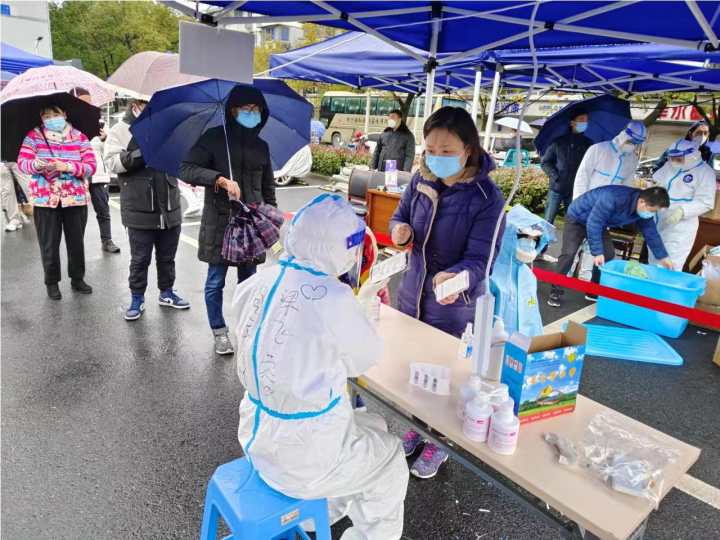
[649,139,716,270]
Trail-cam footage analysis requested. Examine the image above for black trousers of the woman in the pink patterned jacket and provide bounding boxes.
[33,206,87,285]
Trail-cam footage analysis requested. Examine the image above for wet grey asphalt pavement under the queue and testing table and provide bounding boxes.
[1,179,720,540]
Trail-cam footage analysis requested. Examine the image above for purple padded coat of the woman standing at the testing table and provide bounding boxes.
[390,154,505,336]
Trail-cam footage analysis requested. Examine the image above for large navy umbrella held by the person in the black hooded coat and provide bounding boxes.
[130,79,313,176]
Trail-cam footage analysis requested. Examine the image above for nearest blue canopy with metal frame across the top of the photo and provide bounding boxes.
[176,0,720,115]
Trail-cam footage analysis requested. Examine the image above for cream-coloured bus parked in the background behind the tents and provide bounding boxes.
[320,92,469,146]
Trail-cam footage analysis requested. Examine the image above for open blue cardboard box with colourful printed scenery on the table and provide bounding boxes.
[502,322,587,424]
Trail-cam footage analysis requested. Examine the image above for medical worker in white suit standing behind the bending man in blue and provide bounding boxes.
[573,120,647,284]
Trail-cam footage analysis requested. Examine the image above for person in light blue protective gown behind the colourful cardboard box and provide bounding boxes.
[490,205,556,337]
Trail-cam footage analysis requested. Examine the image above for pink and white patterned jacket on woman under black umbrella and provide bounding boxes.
[17,124,97,208]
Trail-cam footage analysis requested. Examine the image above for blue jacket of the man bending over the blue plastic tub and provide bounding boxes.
[567,185,668,259]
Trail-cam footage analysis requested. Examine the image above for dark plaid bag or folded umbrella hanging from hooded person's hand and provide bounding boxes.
[222,203,284,264]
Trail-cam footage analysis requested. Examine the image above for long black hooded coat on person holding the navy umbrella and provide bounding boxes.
[180,86,277,266]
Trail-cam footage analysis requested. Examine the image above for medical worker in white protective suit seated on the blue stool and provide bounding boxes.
[234,194,408,540]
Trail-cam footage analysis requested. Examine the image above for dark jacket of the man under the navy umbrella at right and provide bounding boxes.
[542,133,593,195]
